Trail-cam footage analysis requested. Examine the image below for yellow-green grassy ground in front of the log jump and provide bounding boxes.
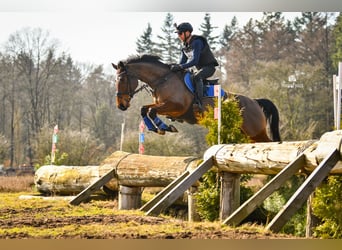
[0,176,291,239]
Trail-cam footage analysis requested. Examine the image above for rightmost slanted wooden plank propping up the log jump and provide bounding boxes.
[266,149,340,232]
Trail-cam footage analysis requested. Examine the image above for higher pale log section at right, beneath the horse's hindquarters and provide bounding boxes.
[204,130,342,175]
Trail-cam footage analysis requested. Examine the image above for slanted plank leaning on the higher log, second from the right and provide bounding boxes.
[223,153,305,226]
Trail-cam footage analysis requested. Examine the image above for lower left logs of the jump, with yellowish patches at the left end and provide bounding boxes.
[35,151,199,195]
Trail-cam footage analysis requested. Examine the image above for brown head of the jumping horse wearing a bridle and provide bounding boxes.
[112,61,138,111]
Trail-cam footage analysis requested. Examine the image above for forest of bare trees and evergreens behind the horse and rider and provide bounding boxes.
[0,12,342,168]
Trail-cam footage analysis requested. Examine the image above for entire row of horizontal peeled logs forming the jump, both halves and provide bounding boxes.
[35,130,342,195]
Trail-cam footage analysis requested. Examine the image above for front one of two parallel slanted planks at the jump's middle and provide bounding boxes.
[146,156,214,215]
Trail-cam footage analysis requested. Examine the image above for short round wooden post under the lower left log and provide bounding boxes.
[118,186,141,210]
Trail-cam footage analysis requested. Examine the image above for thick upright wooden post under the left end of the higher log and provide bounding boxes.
[220,172,240,221]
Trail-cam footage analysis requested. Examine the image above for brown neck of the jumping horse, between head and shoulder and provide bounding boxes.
[132,64,168,89]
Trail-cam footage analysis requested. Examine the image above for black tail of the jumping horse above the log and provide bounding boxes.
[255,99,281,141]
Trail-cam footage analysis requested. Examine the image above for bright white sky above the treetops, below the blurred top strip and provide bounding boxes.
[0,11,298,69]
